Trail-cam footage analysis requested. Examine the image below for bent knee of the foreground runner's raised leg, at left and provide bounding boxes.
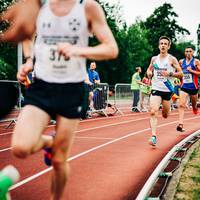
[12,144,31,158]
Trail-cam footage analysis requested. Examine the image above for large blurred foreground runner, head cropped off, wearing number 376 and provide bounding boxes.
[0,0,118,200]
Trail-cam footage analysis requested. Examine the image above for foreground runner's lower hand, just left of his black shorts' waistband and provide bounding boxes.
[17,63,33,83]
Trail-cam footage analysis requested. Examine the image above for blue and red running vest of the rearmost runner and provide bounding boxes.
[181,58,198,90]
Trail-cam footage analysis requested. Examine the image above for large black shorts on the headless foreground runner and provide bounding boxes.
[24,79,88,119]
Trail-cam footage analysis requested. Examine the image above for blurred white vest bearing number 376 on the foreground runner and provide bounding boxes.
[34,0,89,83]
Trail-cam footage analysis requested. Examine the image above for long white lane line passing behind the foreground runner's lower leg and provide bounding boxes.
[10,116,200,190]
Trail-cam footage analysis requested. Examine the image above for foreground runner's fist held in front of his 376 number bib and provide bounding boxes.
[57,43,80,59]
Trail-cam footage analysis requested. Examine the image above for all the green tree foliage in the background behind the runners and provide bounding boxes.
[0,0,197,84]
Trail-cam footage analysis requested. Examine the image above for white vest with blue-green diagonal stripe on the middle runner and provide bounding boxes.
[152,54,175,92]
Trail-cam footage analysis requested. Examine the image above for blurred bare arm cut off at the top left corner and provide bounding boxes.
[0,0,40,42]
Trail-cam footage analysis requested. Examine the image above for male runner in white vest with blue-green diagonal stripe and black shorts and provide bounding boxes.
[147,36,182,146]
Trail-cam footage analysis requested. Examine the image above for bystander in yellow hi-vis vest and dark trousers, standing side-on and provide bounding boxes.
[131,67,142,112]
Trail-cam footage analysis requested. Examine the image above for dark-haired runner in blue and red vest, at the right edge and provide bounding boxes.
[176,46,200,132]
